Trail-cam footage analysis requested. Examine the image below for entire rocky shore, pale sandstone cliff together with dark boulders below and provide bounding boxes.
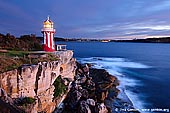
[0,51,138,113]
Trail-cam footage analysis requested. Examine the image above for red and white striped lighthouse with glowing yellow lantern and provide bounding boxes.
[41,17,55,52]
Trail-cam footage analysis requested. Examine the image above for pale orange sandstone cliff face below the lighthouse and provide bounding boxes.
[0,51,76,113]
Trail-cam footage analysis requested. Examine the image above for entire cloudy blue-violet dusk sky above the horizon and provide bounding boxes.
[0,0,170,39]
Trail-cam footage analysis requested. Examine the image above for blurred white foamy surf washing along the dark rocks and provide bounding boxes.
[77,57,151,113]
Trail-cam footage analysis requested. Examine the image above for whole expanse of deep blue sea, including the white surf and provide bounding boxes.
[57,42,170,112]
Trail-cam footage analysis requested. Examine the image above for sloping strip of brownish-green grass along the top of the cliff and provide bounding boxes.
[0,51,59,73]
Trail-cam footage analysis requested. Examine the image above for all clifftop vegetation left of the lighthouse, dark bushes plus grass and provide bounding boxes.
[0,33,59,73]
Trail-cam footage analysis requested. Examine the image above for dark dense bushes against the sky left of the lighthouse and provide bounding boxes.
[0,33,42,51]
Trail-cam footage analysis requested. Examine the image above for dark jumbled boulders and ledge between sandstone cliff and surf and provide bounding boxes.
[55,63,138,113]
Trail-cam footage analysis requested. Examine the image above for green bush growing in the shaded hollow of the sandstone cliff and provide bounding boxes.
[53,76,66,98]
